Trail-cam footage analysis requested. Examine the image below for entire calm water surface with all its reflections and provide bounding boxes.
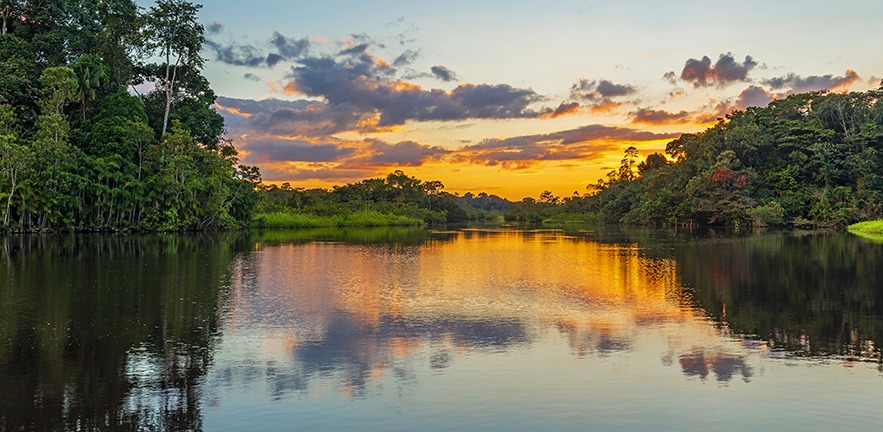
[0,227,883,431]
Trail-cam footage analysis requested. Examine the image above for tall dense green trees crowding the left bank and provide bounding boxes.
[0,0,260,231]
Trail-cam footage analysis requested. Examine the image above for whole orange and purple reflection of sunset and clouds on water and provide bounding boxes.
[212,230,757,402]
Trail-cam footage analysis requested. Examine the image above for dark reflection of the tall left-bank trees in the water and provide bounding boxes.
[0,235,244,430]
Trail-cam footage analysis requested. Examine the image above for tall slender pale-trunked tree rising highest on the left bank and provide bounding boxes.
[144,0,205,135]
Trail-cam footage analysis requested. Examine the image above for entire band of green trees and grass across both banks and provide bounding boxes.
[0,0,883,232]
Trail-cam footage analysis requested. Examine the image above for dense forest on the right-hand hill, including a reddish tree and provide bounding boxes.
[506,88,883,228]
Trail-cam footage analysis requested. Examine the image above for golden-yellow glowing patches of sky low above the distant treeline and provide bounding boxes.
[237,97,704,201]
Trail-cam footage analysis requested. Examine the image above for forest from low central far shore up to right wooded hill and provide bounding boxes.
[261,89,883,228]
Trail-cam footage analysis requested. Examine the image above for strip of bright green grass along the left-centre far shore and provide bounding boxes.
[251,211,423,228]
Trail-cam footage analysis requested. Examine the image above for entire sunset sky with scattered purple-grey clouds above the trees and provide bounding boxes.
[148,0,883,200]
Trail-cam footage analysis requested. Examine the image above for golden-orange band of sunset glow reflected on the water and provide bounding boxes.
[234,230,693,328]
